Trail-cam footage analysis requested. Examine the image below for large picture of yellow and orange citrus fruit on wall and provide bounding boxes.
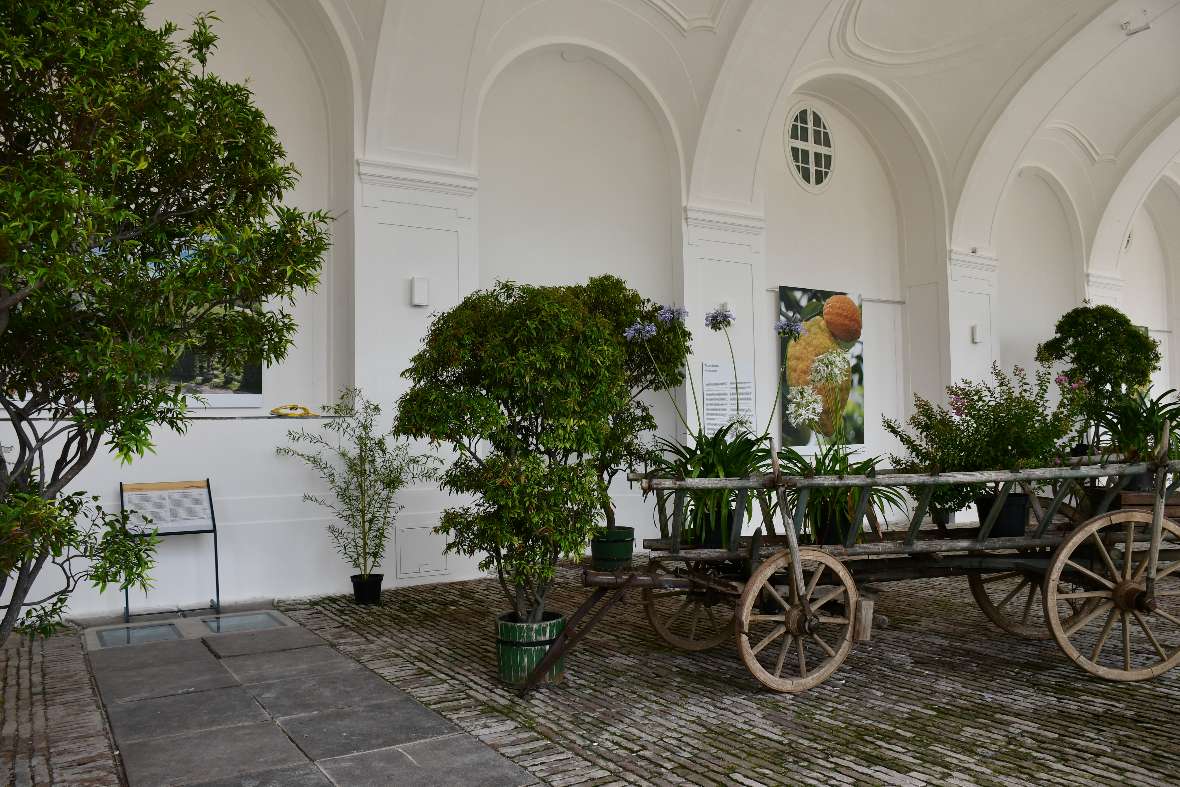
[779,287,865,446]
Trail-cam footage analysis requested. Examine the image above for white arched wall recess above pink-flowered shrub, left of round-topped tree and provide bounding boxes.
[994,171,1083,369]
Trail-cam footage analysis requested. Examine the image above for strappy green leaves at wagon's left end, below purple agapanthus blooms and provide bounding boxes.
[651,424,771,547]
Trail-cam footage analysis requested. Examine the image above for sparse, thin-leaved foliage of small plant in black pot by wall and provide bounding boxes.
[275,388,438,577]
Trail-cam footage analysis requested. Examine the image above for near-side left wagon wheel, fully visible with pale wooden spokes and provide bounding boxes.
[738,549,858,691]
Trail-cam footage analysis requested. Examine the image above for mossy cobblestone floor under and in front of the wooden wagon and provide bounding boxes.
[284,570,1180,785]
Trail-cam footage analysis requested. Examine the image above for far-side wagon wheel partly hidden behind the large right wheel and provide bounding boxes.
[966,554,1096,640]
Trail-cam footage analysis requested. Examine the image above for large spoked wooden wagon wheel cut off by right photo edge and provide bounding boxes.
[1044,511,1180,681]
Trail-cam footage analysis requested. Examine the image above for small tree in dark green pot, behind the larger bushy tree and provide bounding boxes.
[573,276,691,571]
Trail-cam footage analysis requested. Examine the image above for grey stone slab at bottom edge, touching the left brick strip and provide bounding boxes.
[116,720,307,787]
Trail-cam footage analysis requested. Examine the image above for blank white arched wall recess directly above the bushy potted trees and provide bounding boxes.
[478,48,682,532]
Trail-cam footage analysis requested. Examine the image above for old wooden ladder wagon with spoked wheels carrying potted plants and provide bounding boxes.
[522,461,1180,694]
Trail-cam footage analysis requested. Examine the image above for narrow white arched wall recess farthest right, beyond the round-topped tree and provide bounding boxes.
[1119,209,1171,393]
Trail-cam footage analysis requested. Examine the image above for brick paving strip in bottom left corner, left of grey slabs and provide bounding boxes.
[0,635,120,787]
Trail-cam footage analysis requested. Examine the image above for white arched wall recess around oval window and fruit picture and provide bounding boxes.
[760,100,905,453]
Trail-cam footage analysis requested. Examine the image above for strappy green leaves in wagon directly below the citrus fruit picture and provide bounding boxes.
[779,439,905,544]
